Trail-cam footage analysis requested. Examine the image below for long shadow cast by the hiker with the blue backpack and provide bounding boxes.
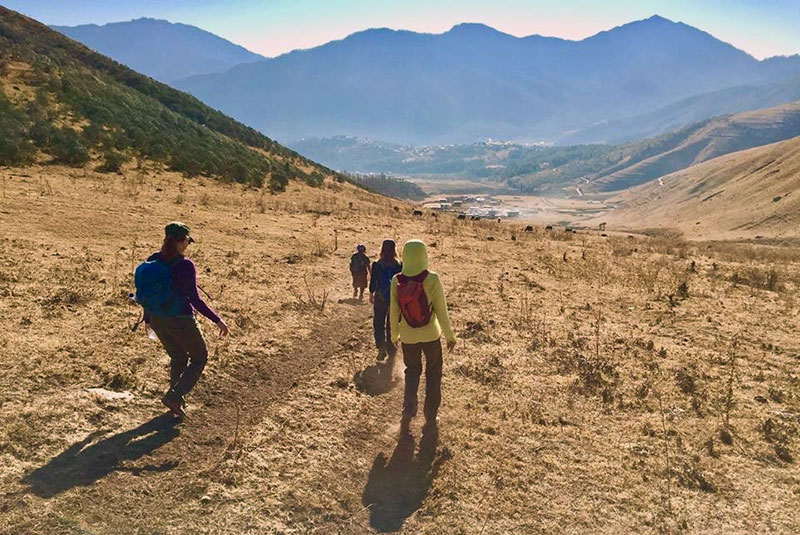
[21,413,180,498]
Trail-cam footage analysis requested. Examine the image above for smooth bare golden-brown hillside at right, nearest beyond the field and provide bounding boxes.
[604,137,800,239]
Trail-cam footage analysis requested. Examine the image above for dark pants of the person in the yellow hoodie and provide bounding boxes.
[403,339,442,420]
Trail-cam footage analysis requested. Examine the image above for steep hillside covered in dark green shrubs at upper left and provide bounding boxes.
[0,7,329,188]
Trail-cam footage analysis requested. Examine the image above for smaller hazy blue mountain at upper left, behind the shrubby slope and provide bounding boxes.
[52,18,266,82]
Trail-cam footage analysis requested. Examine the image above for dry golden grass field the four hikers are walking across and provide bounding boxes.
[0,166,800,535]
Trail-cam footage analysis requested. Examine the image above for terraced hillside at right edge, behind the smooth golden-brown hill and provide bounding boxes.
[585,102,800,191]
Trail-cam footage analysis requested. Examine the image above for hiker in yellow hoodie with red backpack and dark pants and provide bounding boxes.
[389,240,456,433]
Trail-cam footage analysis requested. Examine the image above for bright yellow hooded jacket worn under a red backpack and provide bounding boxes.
[389,240,456,344]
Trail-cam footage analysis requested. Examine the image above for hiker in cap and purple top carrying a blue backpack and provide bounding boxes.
[135,221,228,417]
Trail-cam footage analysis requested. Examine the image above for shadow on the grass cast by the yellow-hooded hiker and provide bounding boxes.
[361,430,448,533]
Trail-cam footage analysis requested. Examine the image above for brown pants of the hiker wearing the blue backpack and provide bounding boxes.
[150,316,208,400]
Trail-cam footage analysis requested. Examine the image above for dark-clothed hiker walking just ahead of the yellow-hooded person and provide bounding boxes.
[369,240,403,360]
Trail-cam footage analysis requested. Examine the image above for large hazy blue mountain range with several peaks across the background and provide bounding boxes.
[176,17,800,145]
